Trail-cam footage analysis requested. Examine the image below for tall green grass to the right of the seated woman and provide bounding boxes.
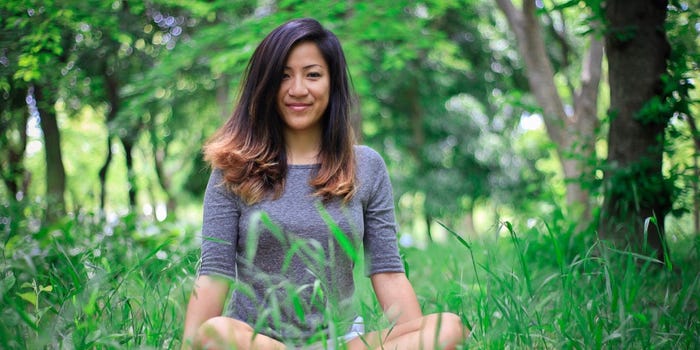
[407,223,700,349]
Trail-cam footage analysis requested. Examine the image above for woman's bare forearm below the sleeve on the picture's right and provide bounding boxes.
[370,272,423,324]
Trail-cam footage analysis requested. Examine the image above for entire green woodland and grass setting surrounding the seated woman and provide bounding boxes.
[0,0,700,349]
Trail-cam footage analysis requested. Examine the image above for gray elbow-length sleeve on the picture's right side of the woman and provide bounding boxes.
[363,151,404,276]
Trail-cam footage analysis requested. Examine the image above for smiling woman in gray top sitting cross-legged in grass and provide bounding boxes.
[183,19,468,349]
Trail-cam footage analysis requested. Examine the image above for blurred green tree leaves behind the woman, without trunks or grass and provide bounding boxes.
[0,0,697,235]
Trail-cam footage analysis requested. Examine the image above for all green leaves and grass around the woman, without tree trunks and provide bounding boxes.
[0,0,700,349]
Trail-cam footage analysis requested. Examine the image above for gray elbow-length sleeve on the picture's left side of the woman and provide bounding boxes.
[199,169,240,279]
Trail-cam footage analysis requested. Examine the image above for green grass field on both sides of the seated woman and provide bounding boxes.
[0,204,700,349]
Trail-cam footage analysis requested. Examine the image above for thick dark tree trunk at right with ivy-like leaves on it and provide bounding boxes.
[599,0,672,261]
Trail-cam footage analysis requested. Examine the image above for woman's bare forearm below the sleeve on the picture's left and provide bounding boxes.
[182,275,229,349]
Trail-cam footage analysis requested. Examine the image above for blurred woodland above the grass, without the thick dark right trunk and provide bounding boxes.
[0,0,700,245]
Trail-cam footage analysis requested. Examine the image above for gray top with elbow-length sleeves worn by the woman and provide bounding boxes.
[199,146,404,341]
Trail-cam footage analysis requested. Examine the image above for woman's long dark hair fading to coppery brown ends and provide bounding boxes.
[204,18,356,204]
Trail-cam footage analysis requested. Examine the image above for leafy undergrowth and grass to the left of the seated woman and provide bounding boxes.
[0,203,198,349]
